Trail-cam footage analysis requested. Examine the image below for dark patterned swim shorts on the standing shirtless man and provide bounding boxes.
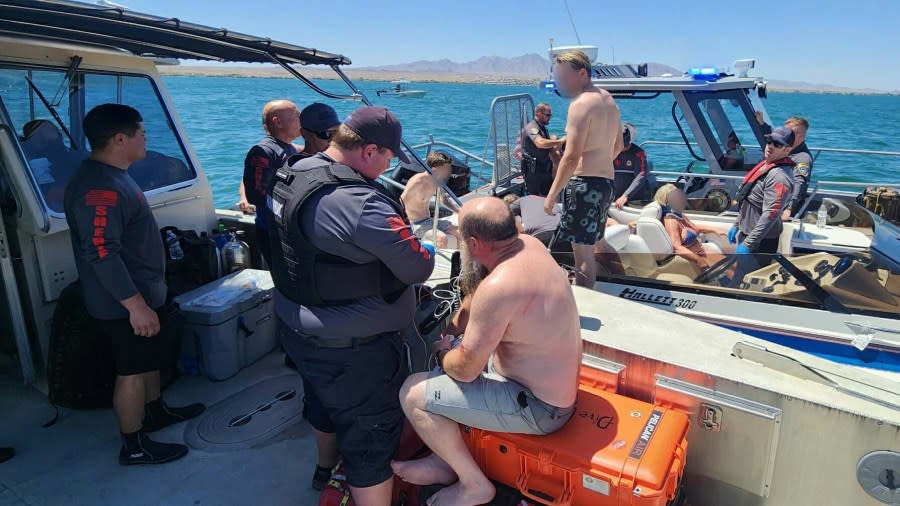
[556,176,616,245]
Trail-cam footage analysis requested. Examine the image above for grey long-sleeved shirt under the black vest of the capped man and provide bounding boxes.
[275,176,434,338]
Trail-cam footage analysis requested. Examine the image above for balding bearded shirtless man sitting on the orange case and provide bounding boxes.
[392,197,581,505]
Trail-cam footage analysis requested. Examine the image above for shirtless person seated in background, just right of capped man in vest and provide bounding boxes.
[400,151,459,248]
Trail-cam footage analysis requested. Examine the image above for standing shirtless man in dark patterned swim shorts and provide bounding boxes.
[544,50,624,288]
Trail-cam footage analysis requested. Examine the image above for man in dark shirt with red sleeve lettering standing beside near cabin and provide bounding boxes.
[65,104,204,465]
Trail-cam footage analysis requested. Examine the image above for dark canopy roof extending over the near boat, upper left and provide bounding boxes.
[0,0,350,65]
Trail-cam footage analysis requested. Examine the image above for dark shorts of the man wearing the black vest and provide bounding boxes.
[279,325,409,488]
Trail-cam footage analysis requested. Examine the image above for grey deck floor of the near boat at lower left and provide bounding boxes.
[0,352,318,506]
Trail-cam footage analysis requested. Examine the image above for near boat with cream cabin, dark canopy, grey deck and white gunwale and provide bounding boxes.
[0,1,900,506]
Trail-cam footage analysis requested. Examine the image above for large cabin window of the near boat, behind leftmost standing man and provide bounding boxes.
[0,67,196,217]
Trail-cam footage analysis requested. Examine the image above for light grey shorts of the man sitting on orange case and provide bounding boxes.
[425,371,575,435]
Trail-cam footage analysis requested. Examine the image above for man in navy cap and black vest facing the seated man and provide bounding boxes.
[268,107,434,506]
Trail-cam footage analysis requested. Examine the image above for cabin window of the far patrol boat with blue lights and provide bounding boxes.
[686,90,763,172]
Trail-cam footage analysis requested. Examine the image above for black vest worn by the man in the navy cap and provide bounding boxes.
[267,156,408,306]
